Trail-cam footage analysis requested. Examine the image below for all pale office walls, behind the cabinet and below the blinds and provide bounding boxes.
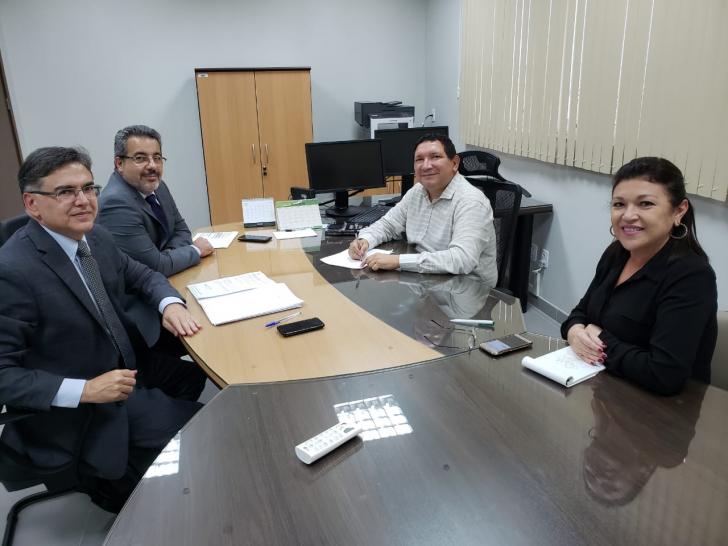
[0,0,728,311]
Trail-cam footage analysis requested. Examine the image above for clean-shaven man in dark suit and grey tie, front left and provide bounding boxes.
[0,147,200,511]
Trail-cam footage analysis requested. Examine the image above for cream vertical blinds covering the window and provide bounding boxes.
[460,0,728,201]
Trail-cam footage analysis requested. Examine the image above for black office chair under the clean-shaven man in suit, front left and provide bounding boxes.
[0,410,90,546]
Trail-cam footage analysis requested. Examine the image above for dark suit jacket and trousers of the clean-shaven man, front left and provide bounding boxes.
[0,220,189,478]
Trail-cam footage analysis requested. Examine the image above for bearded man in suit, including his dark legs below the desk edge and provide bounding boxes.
[98,125,212,400]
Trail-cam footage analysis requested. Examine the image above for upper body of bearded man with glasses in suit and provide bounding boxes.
[99,125,212,277]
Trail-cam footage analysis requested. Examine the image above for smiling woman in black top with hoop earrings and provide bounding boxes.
[561,157,717,394]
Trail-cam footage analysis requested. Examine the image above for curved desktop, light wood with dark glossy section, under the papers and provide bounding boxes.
[171,224,524,386]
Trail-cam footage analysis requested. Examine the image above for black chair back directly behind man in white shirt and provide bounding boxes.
[467,178,521,293]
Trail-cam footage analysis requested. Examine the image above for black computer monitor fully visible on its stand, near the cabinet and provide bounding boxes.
[306,140,386,218]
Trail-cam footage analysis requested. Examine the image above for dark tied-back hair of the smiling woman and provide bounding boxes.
[612,157,708,260]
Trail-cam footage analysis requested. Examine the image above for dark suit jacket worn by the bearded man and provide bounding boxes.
[98,172,200,277]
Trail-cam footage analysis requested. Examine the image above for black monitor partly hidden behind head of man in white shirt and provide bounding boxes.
[374,125,449,195]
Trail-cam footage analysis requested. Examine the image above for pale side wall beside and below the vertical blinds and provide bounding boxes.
[425,0,728,313]
